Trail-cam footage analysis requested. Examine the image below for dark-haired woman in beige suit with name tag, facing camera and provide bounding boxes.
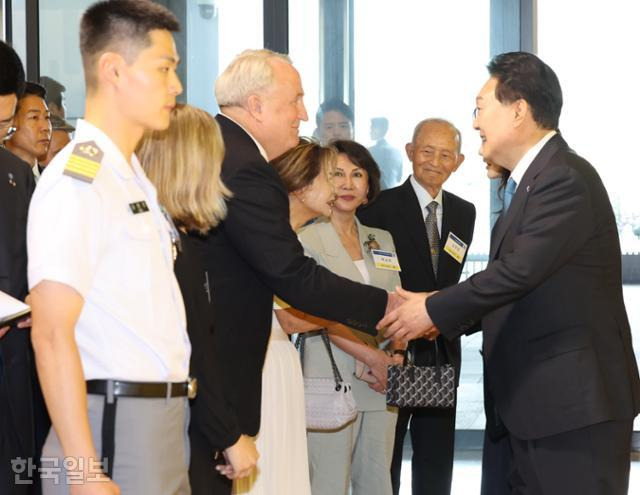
[299,140,400,495]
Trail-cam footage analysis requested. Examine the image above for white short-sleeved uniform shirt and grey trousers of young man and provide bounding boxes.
[27,120,191,494]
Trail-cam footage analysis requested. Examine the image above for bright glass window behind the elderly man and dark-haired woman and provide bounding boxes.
[289,0,490,254]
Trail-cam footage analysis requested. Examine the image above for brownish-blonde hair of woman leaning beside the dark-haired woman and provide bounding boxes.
[271,138,338,193]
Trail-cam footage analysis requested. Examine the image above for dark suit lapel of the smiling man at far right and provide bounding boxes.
[489,134,567,261]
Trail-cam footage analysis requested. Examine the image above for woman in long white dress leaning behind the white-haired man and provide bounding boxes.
[233,142,336,495]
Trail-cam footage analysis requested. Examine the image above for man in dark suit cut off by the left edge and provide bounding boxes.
[0,41,36,495]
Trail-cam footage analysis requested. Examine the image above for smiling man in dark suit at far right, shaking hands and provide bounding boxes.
[381,52,640,495]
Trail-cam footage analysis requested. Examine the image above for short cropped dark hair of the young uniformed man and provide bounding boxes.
[80,0,180,87]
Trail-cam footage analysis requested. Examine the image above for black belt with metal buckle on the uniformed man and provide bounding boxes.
[87,379,196,399]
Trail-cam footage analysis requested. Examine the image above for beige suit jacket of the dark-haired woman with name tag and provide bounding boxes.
[298,220,400,411]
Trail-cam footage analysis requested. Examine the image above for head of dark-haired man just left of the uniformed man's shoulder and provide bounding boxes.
[6,82,51,180]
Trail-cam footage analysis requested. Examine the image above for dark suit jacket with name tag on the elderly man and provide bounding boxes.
[358,179,476,381]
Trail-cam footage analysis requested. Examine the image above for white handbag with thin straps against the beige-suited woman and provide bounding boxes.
[296,329,358,430]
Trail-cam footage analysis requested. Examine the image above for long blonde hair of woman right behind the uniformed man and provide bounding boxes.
[136,103,231,233]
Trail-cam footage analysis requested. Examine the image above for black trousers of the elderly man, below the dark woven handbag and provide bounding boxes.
[391,408,456,495]
